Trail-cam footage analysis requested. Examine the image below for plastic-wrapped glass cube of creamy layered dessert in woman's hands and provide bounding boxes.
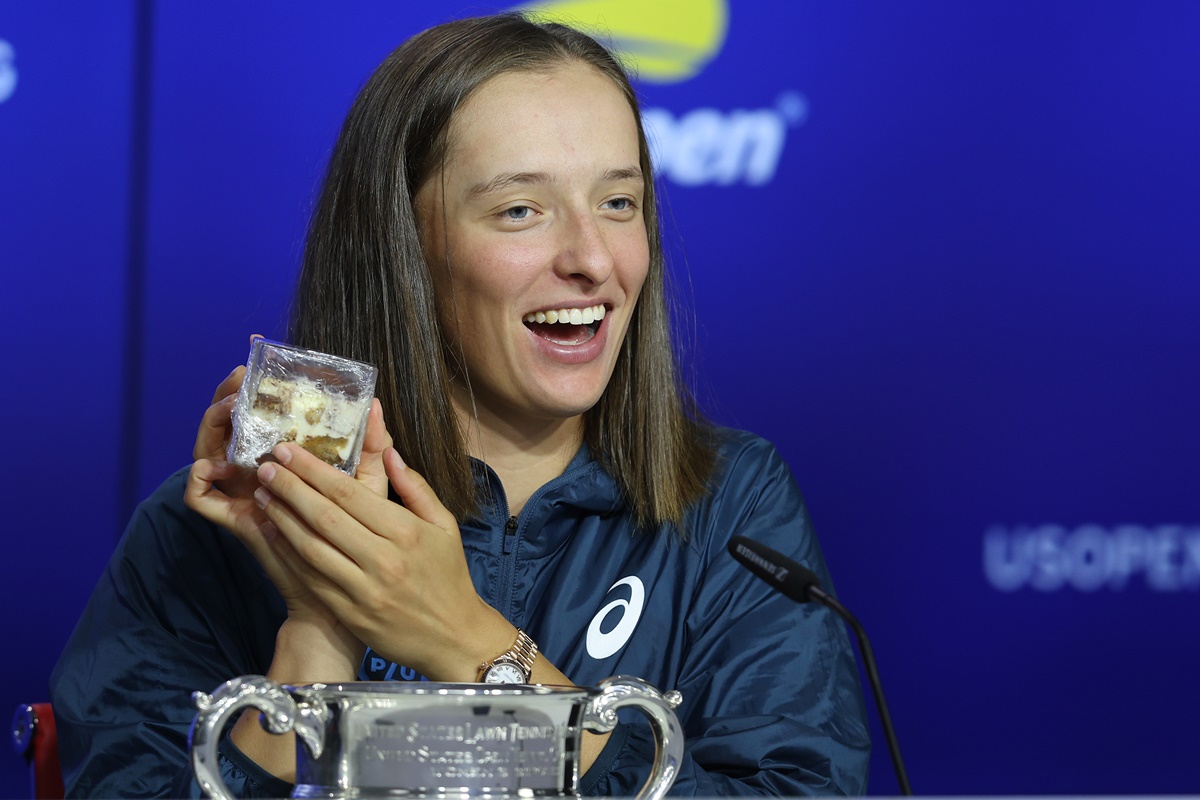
[228,339,377,475]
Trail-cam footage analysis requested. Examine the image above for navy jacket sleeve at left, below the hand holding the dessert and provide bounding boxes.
[50,471,284,798]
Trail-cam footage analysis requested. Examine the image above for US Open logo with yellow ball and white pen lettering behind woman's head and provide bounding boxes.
[518,0,809,186]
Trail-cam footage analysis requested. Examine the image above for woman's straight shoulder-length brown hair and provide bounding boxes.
[289,13,714,527]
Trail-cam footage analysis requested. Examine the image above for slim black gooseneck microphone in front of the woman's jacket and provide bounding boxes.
[728,536,912,795]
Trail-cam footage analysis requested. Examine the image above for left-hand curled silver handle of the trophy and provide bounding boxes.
[188,675,328,800]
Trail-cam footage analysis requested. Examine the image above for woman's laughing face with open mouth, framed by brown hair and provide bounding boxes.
[416,64,649,426]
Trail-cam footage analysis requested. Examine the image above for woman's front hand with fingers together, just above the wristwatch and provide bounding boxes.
[250,444,515,681]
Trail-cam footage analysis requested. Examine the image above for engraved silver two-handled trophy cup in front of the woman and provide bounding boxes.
[191,675,683,800]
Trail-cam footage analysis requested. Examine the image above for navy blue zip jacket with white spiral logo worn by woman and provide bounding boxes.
[50,431,869,798]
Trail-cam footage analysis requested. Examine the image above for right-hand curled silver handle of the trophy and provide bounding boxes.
[583,675,683,800]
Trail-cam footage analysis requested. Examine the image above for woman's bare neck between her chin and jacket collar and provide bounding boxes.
[455,393,583,516]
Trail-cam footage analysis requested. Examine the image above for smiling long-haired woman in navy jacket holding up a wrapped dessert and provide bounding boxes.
[46,9,869,796]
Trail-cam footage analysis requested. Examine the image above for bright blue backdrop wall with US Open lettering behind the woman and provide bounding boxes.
[0,0,1200,796]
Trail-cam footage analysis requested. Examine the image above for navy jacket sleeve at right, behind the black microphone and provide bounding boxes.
[581,439,870,796]
